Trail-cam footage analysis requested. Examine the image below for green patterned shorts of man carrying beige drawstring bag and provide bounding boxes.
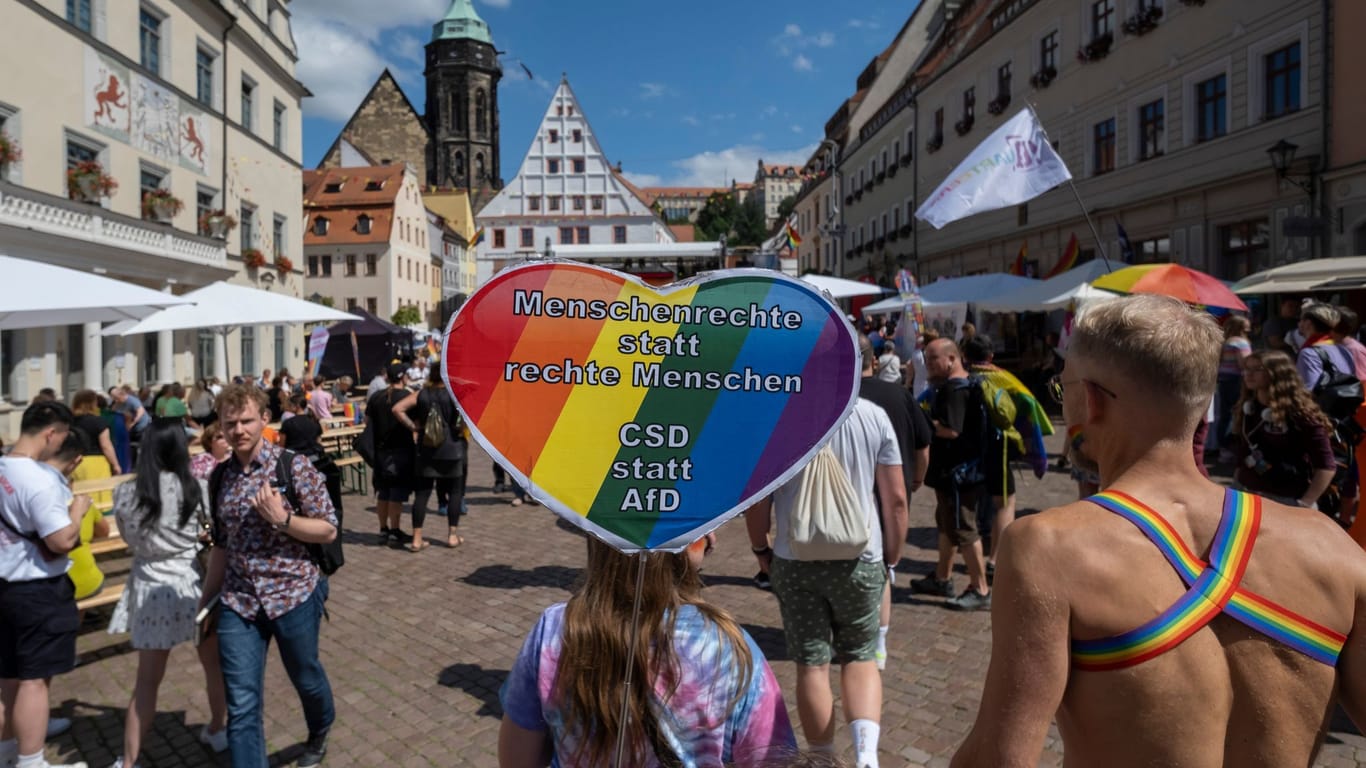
[770,558,887,667]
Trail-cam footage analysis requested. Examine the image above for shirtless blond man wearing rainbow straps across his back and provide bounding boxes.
[952,289,1366,768]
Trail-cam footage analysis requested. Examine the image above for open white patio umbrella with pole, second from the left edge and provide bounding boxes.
[104,282,361,379]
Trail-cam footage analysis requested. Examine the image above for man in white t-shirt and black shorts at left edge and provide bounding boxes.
[0,402,90,768]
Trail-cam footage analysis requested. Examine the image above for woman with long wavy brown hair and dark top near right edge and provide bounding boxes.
[1229,351,1337,514]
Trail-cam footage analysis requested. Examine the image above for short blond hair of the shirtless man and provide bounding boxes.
[1068,294,1224,420]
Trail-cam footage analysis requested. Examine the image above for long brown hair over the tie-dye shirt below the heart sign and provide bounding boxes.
[555,536,753,765]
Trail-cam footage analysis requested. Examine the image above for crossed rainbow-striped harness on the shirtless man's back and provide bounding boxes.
[1072,489,1347,671]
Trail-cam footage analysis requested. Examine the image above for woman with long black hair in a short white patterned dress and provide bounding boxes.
[109,421,228,768]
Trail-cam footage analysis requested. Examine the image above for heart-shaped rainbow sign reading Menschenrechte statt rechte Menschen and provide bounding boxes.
[441,261,859,552]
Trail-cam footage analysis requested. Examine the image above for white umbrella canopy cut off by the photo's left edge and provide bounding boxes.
[0,256,191,331]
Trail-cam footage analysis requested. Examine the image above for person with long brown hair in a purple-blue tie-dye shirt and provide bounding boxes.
[499,534,795,768]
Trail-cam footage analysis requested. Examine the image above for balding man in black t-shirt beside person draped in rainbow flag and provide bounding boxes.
[911,339,992,611]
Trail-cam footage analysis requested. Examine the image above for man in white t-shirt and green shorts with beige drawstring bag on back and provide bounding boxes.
[744,398,907,768]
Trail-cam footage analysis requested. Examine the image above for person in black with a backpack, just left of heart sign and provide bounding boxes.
[393,374,469,552]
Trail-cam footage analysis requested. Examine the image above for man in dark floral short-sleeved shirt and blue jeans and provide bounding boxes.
[204,384,337,768]
